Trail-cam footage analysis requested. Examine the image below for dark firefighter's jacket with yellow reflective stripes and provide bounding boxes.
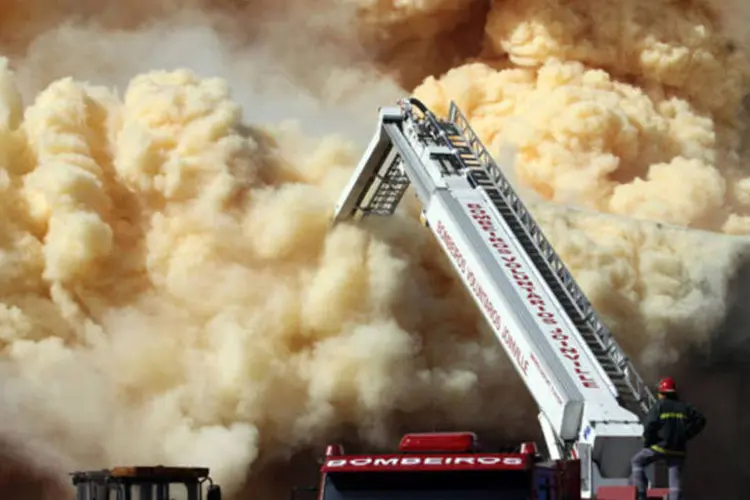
[643,398,706,455]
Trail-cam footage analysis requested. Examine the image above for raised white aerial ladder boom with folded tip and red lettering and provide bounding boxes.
[333,98,654,498]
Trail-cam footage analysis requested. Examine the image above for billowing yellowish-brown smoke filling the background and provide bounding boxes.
[0,0,750,500]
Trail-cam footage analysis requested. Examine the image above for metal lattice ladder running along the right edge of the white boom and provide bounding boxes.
[449,102,655,416]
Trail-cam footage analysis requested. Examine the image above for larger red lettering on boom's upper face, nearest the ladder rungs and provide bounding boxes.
[466,203,599,389]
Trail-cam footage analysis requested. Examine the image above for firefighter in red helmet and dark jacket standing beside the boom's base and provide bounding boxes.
[631,377,706,500]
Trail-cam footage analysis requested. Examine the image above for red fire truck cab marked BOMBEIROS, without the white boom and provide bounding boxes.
[306,432,581,500]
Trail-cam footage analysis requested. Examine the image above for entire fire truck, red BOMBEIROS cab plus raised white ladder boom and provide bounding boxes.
[326,98,667,500]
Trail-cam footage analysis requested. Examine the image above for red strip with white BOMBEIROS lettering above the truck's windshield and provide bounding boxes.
[321,453,532,473]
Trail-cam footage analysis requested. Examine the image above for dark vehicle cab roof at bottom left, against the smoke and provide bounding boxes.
[71,466,221,500]
